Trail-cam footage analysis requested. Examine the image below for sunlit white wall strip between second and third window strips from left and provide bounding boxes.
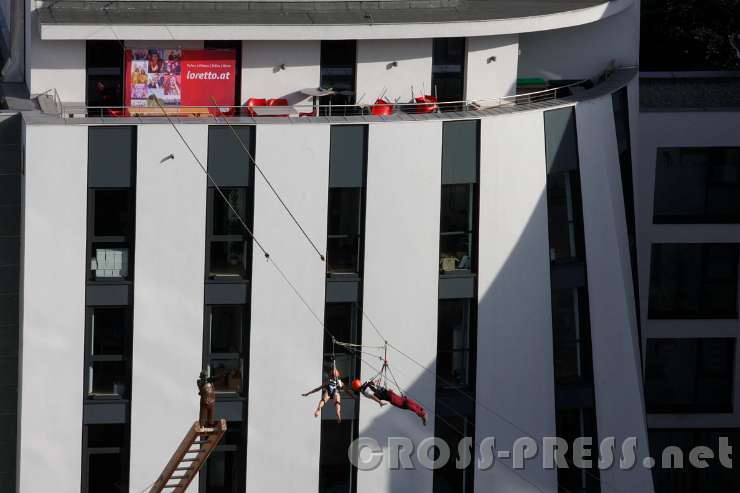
[247,125,329,491]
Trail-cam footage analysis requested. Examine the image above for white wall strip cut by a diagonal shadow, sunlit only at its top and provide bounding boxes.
[475,111,557,493]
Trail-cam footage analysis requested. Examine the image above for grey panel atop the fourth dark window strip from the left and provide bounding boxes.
[442,120,479,185]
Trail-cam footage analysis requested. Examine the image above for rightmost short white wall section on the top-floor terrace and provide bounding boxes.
[465,34,519,105]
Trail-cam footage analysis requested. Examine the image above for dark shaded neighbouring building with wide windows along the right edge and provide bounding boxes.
[636,1,740,492]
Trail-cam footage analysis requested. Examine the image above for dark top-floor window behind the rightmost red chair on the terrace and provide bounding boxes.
[432,38,465,101]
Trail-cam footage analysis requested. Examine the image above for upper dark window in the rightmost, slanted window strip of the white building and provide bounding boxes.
[547,171,584,262]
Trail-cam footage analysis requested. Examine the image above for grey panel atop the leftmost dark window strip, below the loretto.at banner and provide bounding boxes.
[87,127,137,187]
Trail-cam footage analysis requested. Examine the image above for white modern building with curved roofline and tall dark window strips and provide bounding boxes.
[0,0,712,493]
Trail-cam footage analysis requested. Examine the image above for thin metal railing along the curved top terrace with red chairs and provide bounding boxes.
[59,76,606,121]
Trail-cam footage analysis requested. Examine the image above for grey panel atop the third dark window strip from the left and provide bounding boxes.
[329,125,367,188]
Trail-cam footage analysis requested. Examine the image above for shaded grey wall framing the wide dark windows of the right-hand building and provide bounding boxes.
[635,111,740,428]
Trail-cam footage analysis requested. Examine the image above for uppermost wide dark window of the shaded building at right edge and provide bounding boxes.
[653,147,740,224]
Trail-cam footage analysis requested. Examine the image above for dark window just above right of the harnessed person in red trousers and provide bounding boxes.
[437,299,475,388]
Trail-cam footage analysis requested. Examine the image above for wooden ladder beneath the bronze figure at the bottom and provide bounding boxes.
[149,419,226,493]
